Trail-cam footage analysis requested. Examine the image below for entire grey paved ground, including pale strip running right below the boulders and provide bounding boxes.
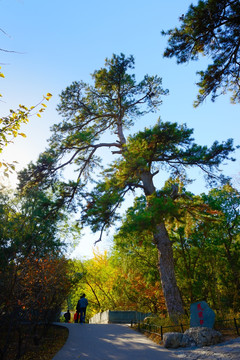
[52,323,240,360]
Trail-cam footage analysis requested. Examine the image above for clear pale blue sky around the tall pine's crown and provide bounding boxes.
[0,0,240,257]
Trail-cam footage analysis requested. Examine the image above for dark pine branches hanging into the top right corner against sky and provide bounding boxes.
[162,0,240,106]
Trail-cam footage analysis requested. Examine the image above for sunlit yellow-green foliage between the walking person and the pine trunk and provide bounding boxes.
[68,249,166,318]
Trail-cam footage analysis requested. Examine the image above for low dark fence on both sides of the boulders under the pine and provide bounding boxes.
[131,318,240,340]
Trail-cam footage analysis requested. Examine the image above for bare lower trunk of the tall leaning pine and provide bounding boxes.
[154,223,184,317]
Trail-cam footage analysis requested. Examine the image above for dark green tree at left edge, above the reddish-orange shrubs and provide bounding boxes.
[0,180,79,312]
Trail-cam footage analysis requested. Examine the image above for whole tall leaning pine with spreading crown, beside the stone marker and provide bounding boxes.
[36,54,233,315]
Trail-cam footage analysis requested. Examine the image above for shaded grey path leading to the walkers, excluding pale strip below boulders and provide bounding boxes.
[53,323,176,360]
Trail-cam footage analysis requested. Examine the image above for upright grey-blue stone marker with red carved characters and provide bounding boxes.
[190,301,215,329]
